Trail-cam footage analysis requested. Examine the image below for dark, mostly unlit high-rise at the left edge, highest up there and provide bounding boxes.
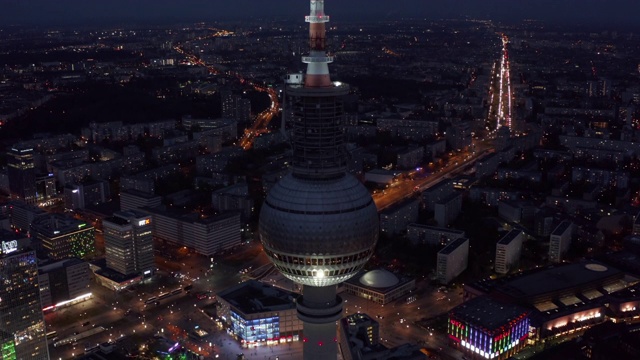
[7,144,36,204]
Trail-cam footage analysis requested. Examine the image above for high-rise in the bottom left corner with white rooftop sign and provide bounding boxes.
[0,240,49,360]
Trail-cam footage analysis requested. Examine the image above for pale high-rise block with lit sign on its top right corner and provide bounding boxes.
[102,210,155,276]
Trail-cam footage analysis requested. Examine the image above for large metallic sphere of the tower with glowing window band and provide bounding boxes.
[260,173,378,286]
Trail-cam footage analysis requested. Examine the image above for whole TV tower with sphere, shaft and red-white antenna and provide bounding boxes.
[260,0,378,360]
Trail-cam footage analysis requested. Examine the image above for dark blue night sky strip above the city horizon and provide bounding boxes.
[0,0,640,27]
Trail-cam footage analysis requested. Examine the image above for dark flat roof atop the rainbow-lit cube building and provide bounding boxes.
[451,296,529,330]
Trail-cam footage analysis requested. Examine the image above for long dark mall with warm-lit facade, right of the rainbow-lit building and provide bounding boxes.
[464,261,633,343]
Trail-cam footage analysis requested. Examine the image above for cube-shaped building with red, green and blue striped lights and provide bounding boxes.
[447,296,530,359]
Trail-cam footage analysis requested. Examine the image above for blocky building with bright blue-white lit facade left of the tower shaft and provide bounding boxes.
[217,280,302,346]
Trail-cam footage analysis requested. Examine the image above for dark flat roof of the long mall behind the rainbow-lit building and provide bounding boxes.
[496,261,624,301]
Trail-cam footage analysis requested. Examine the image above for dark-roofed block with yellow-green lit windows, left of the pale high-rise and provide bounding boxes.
[31,213,96,260]
